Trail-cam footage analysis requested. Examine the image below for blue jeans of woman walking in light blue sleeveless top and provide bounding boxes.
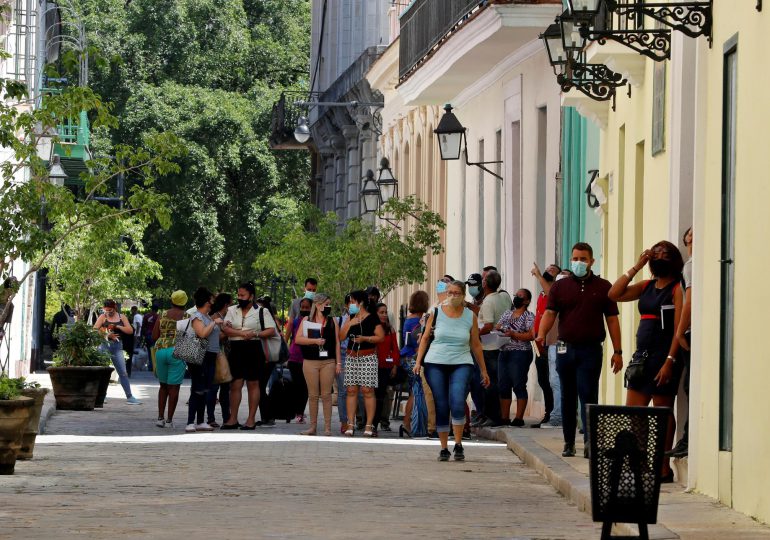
[425,364,473,433]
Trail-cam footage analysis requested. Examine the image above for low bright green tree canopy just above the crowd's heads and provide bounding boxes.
[254,196,446,306]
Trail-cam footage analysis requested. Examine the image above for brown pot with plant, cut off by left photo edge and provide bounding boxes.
[0,375,35,474]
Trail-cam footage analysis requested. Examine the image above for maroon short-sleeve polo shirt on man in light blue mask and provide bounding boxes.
[548,274,618,345]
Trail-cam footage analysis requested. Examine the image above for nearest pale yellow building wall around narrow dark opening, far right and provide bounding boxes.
[691,2,770,522]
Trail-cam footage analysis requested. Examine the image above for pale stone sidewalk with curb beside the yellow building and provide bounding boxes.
[476,419,770,540]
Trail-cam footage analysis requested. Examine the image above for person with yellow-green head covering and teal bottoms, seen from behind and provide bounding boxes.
[151,290,187,429]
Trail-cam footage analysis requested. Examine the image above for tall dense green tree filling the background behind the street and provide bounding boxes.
[76,0,310,291]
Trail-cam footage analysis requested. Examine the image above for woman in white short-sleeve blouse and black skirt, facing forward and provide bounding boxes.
[222,282,268,431]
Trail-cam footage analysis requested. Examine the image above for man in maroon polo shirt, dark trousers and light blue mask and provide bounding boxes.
[537,242,623,457]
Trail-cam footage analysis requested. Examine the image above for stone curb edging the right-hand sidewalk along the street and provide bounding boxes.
[474,428,679,540]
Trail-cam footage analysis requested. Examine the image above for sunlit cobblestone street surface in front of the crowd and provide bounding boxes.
[0,374,600,539]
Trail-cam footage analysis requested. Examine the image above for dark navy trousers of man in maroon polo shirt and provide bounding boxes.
[556,343,602,444]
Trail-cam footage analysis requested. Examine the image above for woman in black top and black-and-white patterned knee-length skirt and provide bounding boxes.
[340,290,385,437]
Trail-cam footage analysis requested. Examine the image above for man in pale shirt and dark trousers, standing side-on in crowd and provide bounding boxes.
[476,270,510,427]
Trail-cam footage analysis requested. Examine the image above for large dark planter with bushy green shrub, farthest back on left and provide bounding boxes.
[48,321,112,411]
